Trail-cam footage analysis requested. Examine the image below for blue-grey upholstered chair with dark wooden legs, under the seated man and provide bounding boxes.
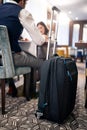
[0,25,31,114]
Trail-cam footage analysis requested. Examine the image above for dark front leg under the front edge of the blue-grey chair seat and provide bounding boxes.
[23,73,31,101]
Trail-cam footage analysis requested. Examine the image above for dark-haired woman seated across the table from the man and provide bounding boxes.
[32,21,49,92]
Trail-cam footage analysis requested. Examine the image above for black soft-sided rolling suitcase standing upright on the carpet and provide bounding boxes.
[36,7,78,123]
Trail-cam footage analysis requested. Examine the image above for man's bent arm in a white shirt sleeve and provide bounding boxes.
[19,9,46,45]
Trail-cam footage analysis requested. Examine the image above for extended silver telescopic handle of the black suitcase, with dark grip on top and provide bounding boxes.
[46,6,60,60]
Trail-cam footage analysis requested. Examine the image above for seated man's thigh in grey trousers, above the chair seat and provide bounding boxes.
[13,52,43,69]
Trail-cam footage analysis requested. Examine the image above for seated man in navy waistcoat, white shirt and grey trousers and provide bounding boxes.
[0,0,47,95]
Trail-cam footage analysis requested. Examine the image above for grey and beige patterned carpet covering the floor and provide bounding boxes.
[0,63,87,130]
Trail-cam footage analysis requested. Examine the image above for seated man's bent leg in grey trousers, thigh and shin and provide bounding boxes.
[13,53,43,98]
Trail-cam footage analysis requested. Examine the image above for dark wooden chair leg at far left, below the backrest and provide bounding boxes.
[1,79,5,114]
